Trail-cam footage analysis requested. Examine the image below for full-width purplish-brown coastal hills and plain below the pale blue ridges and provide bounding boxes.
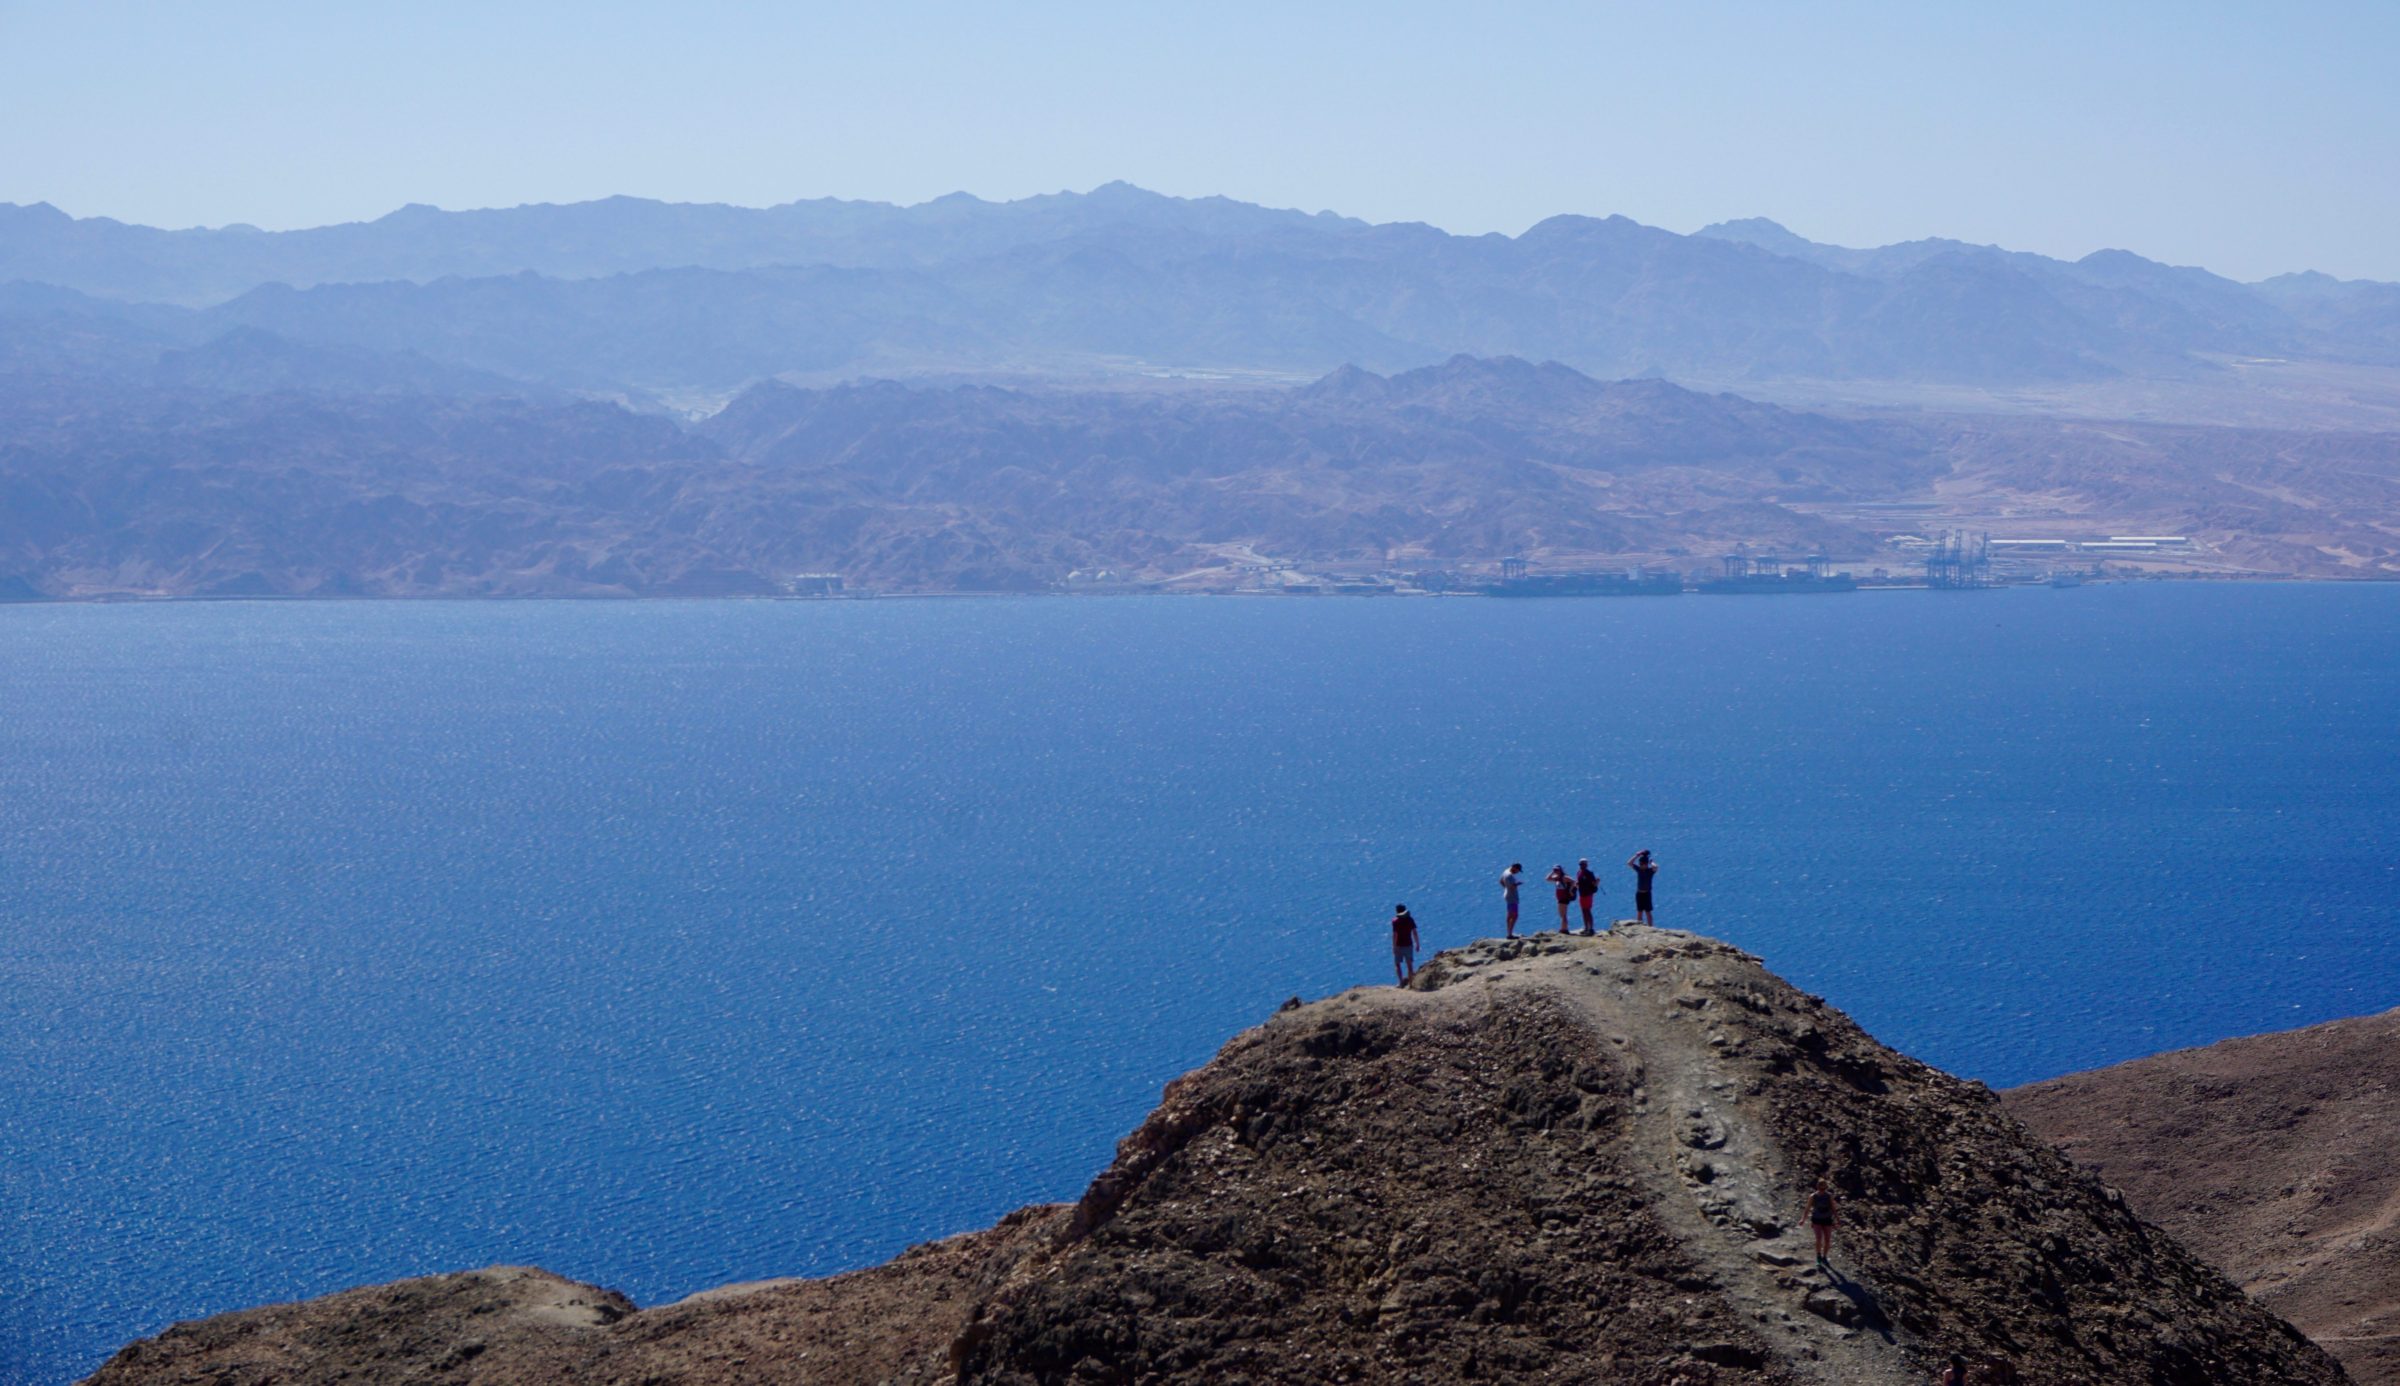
[0,350,2400,597]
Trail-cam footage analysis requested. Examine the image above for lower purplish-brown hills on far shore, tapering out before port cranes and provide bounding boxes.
[0,357,1934,597]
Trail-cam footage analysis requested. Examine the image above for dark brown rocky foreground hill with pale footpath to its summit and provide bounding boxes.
[91,930,2345,1386]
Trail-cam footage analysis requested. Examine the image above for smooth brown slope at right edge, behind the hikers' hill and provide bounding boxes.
[2006,997,2400,1381]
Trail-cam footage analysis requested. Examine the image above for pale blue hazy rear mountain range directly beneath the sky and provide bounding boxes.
[0,185,2400,400]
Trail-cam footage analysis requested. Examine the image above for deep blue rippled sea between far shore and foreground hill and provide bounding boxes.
[0,585,2400,1381]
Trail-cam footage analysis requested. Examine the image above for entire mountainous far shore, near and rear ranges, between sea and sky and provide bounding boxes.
[0,185,2400,597]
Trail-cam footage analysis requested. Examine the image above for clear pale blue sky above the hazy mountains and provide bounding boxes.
[0,0,2400,278]
